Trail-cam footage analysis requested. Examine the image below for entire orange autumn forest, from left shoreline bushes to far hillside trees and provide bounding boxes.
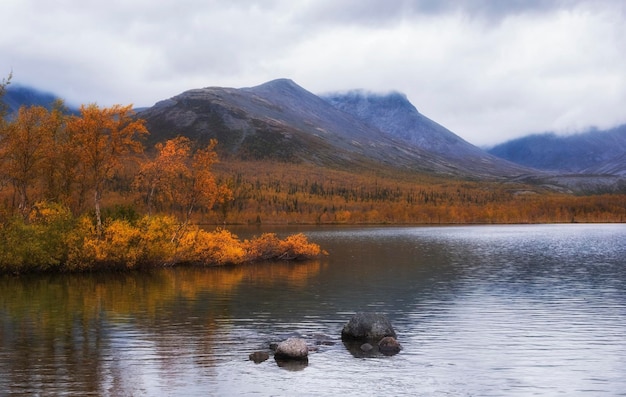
[0,80,626,272]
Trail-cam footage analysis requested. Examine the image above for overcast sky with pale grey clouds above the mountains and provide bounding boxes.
[0,0,626,145]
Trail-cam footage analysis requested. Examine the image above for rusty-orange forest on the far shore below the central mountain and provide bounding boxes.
[215,161,626,224]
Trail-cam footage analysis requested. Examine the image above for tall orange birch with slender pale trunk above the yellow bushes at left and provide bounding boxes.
[67,104,148,232]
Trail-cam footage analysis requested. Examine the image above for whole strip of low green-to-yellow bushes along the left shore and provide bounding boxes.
[0,203,322,273]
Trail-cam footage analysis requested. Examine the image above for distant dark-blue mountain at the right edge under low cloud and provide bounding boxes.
[488,125,626,176]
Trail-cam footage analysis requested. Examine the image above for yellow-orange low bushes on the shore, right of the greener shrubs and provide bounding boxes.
[56,212,323,270]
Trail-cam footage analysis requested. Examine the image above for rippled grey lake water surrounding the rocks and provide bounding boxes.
[0,224,626,396]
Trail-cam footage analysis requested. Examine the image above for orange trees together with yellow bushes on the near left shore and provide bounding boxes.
[0,76,323,273]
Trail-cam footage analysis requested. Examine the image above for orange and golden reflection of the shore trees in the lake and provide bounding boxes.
[0,260,322,395]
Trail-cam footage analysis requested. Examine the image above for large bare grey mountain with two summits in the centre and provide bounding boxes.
[138,79,532,178]
